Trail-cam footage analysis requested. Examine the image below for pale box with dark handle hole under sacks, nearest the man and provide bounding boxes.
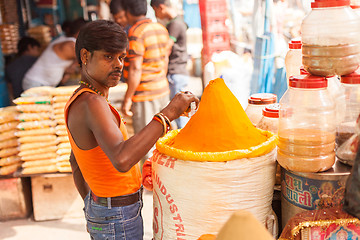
[31,174,84,221]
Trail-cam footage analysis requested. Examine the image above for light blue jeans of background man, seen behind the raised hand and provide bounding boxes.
[167,74,189,128]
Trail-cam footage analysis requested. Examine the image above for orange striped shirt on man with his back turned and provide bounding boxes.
[123,19,169,102]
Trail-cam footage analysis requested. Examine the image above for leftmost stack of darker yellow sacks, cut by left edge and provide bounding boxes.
[0,107,21,175]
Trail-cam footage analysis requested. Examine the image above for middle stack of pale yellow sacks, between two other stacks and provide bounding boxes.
[14,87,58,174]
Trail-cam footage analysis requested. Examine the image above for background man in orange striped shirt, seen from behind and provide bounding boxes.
[121,0,169,157]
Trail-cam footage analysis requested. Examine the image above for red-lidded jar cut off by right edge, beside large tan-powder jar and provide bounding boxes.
[336,72,360,163]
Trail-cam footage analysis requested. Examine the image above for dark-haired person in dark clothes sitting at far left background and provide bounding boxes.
[5,36,40,98]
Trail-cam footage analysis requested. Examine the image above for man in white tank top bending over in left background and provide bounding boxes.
[23,18,86,90]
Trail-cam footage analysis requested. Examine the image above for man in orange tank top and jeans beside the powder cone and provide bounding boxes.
[65,20,199,240]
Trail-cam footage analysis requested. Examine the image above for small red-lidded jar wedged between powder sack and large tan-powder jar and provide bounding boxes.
[257,103,280,134]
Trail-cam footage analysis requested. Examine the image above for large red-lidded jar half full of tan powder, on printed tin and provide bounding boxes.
[277,75,336,172]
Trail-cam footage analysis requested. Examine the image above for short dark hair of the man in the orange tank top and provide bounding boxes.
[75,20,128,66]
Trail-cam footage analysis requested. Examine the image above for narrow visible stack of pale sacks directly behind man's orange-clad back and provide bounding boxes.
[52,86,78,172]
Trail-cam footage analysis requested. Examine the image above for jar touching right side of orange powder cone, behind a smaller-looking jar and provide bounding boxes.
[245,93,277,126]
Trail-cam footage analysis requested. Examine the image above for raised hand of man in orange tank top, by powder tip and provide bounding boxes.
[161,91,200,121]
